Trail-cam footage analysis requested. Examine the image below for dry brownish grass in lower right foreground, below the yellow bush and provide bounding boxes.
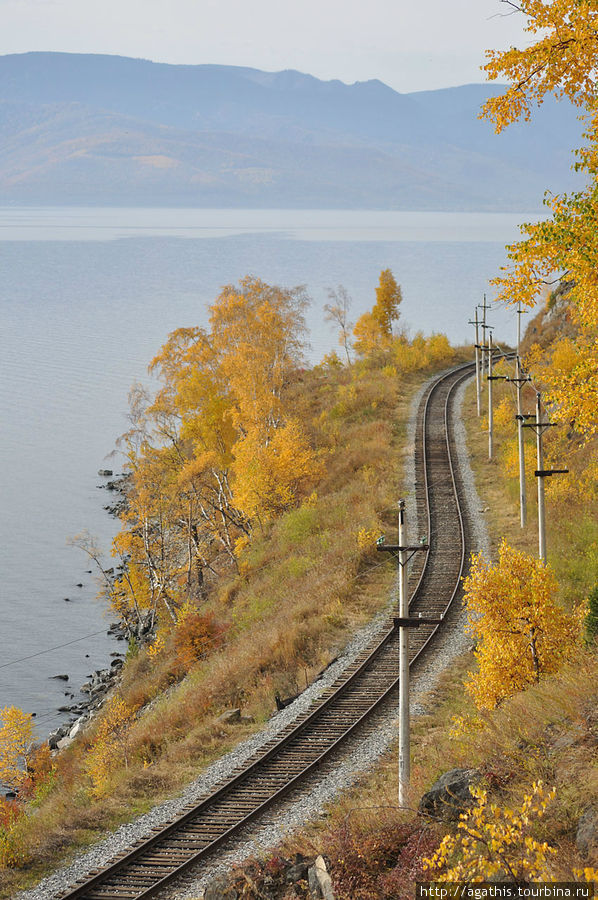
[252,653,598,900]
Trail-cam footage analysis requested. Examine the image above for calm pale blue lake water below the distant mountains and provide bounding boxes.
[0,208,536,734]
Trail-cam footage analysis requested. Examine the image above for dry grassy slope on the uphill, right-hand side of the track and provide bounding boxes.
[243,364,598,900]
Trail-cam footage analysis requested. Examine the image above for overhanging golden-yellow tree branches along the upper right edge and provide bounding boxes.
[482,0,598,435]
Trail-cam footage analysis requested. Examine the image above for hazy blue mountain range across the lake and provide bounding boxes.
[0,53,582,211]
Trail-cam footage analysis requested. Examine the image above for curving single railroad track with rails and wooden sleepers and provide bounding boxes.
[57,364,472,900]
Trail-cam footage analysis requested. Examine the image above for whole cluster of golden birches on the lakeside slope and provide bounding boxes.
[97,277,321,633]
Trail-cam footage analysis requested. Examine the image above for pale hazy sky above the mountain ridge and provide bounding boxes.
[0,0,522,91]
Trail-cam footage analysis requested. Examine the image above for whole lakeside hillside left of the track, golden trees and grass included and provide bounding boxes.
[0,270,463,896]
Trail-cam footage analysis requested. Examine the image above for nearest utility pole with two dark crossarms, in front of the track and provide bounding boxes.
[376,500,432,807]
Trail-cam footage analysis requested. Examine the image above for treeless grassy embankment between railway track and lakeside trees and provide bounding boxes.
[0,351,468,898]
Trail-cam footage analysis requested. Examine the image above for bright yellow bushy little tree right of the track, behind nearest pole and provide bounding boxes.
[464,539,582,709]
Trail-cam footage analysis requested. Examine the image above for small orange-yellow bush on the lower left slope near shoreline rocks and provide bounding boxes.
[85,697,134,797]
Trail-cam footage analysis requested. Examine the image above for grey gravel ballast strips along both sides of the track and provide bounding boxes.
[18,370,489,900]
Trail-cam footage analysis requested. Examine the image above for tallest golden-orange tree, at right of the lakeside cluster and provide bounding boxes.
[210,278,320,522]
